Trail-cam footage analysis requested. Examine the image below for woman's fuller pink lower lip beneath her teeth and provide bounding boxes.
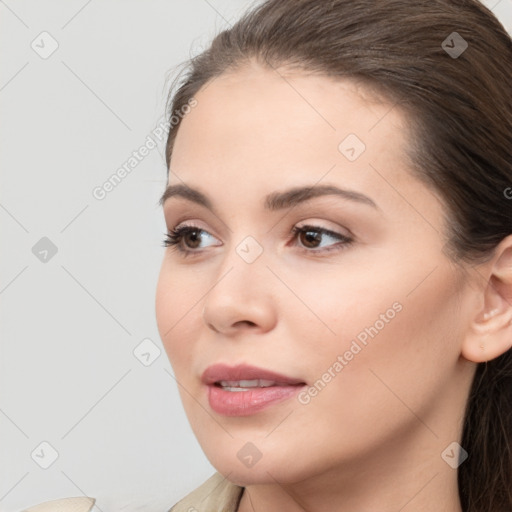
[208,384,304,416]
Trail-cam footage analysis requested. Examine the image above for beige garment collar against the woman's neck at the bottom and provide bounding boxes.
[169,472,244,512]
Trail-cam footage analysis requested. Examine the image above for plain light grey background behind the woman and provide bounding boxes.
[0,0,512,512]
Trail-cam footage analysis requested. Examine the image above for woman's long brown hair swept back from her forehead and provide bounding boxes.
[166,0,512,512]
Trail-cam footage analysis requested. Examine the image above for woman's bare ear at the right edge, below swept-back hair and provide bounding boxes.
[462,235,512,363]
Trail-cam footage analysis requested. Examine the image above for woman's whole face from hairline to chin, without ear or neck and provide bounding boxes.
[156,65,473,485]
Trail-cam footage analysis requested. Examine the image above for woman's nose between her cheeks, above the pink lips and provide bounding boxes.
[202,254,278,336]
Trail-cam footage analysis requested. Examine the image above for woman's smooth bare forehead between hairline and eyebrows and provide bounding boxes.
[169,63,416,206]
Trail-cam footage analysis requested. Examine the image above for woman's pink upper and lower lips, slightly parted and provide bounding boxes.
[201,364,305,416]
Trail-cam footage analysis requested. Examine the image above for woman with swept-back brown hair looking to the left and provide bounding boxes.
[156,0,512,512]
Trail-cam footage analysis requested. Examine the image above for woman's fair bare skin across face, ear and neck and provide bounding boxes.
[156,63,512,512]
